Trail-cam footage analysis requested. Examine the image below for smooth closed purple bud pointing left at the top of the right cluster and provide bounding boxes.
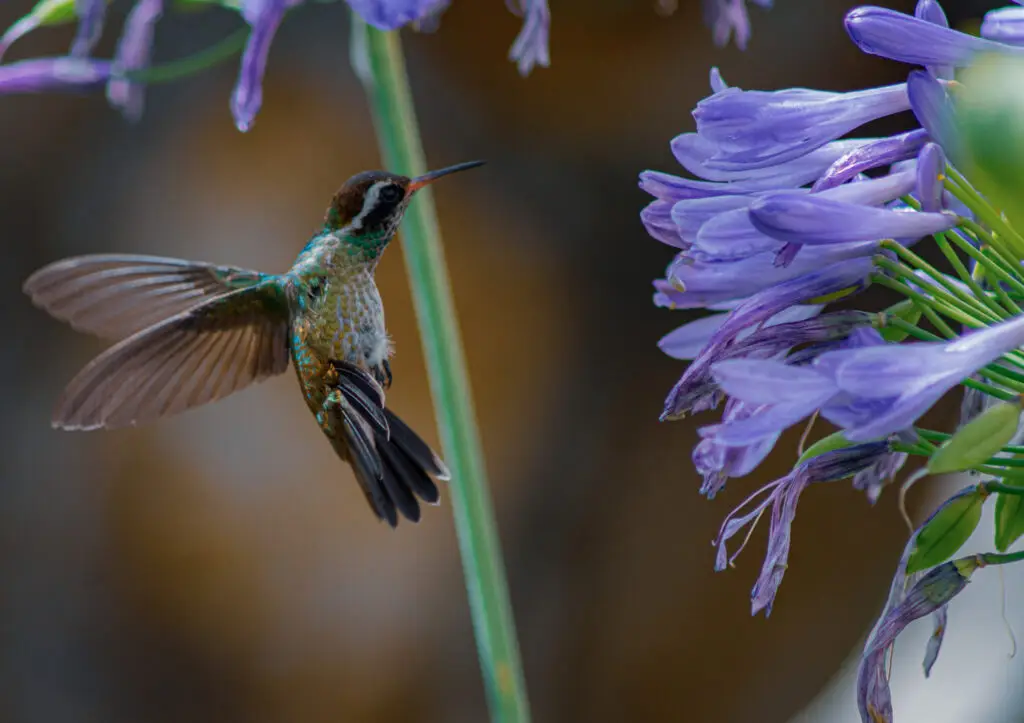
[846,6,1020,68]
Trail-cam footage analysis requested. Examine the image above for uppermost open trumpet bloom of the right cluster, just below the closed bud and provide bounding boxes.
[693,83,910,170]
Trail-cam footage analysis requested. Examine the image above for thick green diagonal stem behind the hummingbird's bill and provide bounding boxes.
[352,14,529,723]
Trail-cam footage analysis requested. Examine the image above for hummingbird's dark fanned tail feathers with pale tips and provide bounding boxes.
[324,362,450,527]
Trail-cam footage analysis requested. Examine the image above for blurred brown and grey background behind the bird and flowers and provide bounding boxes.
[0,0,1024,723]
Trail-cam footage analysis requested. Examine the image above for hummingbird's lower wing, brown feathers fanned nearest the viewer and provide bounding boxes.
[53,279,289,429]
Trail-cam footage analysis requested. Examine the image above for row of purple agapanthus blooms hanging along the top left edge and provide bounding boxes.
[0,0,550,131]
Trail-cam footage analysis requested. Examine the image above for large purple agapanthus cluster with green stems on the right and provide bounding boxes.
[640,0,1024,723]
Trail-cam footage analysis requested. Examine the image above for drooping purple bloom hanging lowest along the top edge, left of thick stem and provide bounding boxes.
[231,0,284,132]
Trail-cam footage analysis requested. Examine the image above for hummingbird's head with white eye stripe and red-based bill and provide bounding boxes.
[324,161,483,237]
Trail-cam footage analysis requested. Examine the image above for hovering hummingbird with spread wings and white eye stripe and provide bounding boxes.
[24,161,483,527]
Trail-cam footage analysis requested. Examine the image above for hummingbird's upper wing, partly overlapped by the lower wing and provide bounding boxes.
[24,254,267,340]
